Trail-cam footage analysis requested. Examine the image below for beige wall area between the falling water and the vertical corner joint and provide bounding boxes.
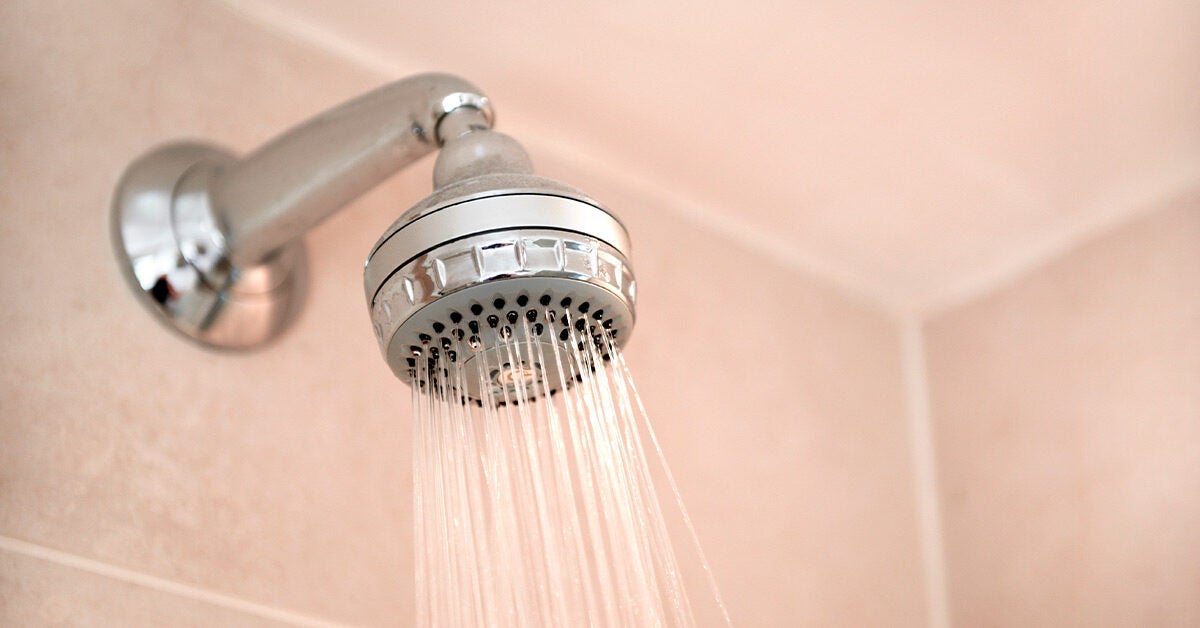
[535,155,924,626]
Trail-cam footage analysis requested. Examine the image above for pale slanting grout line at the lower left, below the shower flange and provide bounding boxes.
[0,536,346,628]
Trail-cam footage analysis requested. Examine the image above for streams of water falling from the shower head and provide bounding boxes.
[413,312,728,626]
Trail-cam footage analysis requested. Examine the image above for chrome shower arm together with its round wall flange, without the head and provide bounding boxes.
[112,73,532,349]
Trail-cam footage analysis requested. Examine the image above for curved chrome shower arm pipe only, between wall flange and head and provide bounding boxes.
[211,73,493,267]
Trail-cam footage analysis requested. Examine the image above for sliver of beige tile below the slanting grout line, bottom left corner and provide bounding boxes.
[0,542,289,628]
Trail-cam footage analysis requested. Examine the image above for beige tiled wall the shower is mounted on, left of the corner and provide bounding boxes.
[0,0,923,626]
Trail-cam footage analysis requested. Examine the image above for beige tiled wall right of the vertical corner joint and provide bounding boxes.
[926,199,1200,626]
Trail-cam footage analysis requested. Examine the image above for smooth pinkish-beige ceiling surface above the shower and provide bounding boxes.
[229,0,1200,304]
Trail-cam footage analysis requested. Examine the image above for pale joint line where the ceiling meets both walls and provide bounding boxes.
[214,0,1200,317]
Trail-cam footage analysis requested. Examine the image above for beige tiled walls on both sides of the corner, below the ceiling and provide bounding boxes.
[0,0,1200,626]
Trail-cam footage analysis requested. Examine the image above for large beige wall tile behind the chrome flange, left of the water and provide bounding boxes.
[0,0,428,626]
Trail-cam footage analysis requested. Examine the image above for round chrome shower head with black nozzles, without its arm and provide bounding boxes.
[364,130,636,400]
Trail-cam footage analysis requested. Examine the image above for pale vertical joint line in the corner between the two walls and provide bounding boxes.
[898,317,950,628]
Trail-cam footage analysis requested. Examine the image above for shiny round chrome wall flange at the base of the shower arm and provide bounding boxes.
[112,144,305,348]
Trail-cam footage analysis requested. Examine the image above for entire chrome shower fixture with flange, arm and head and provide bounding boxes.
[113,74,636,400]
